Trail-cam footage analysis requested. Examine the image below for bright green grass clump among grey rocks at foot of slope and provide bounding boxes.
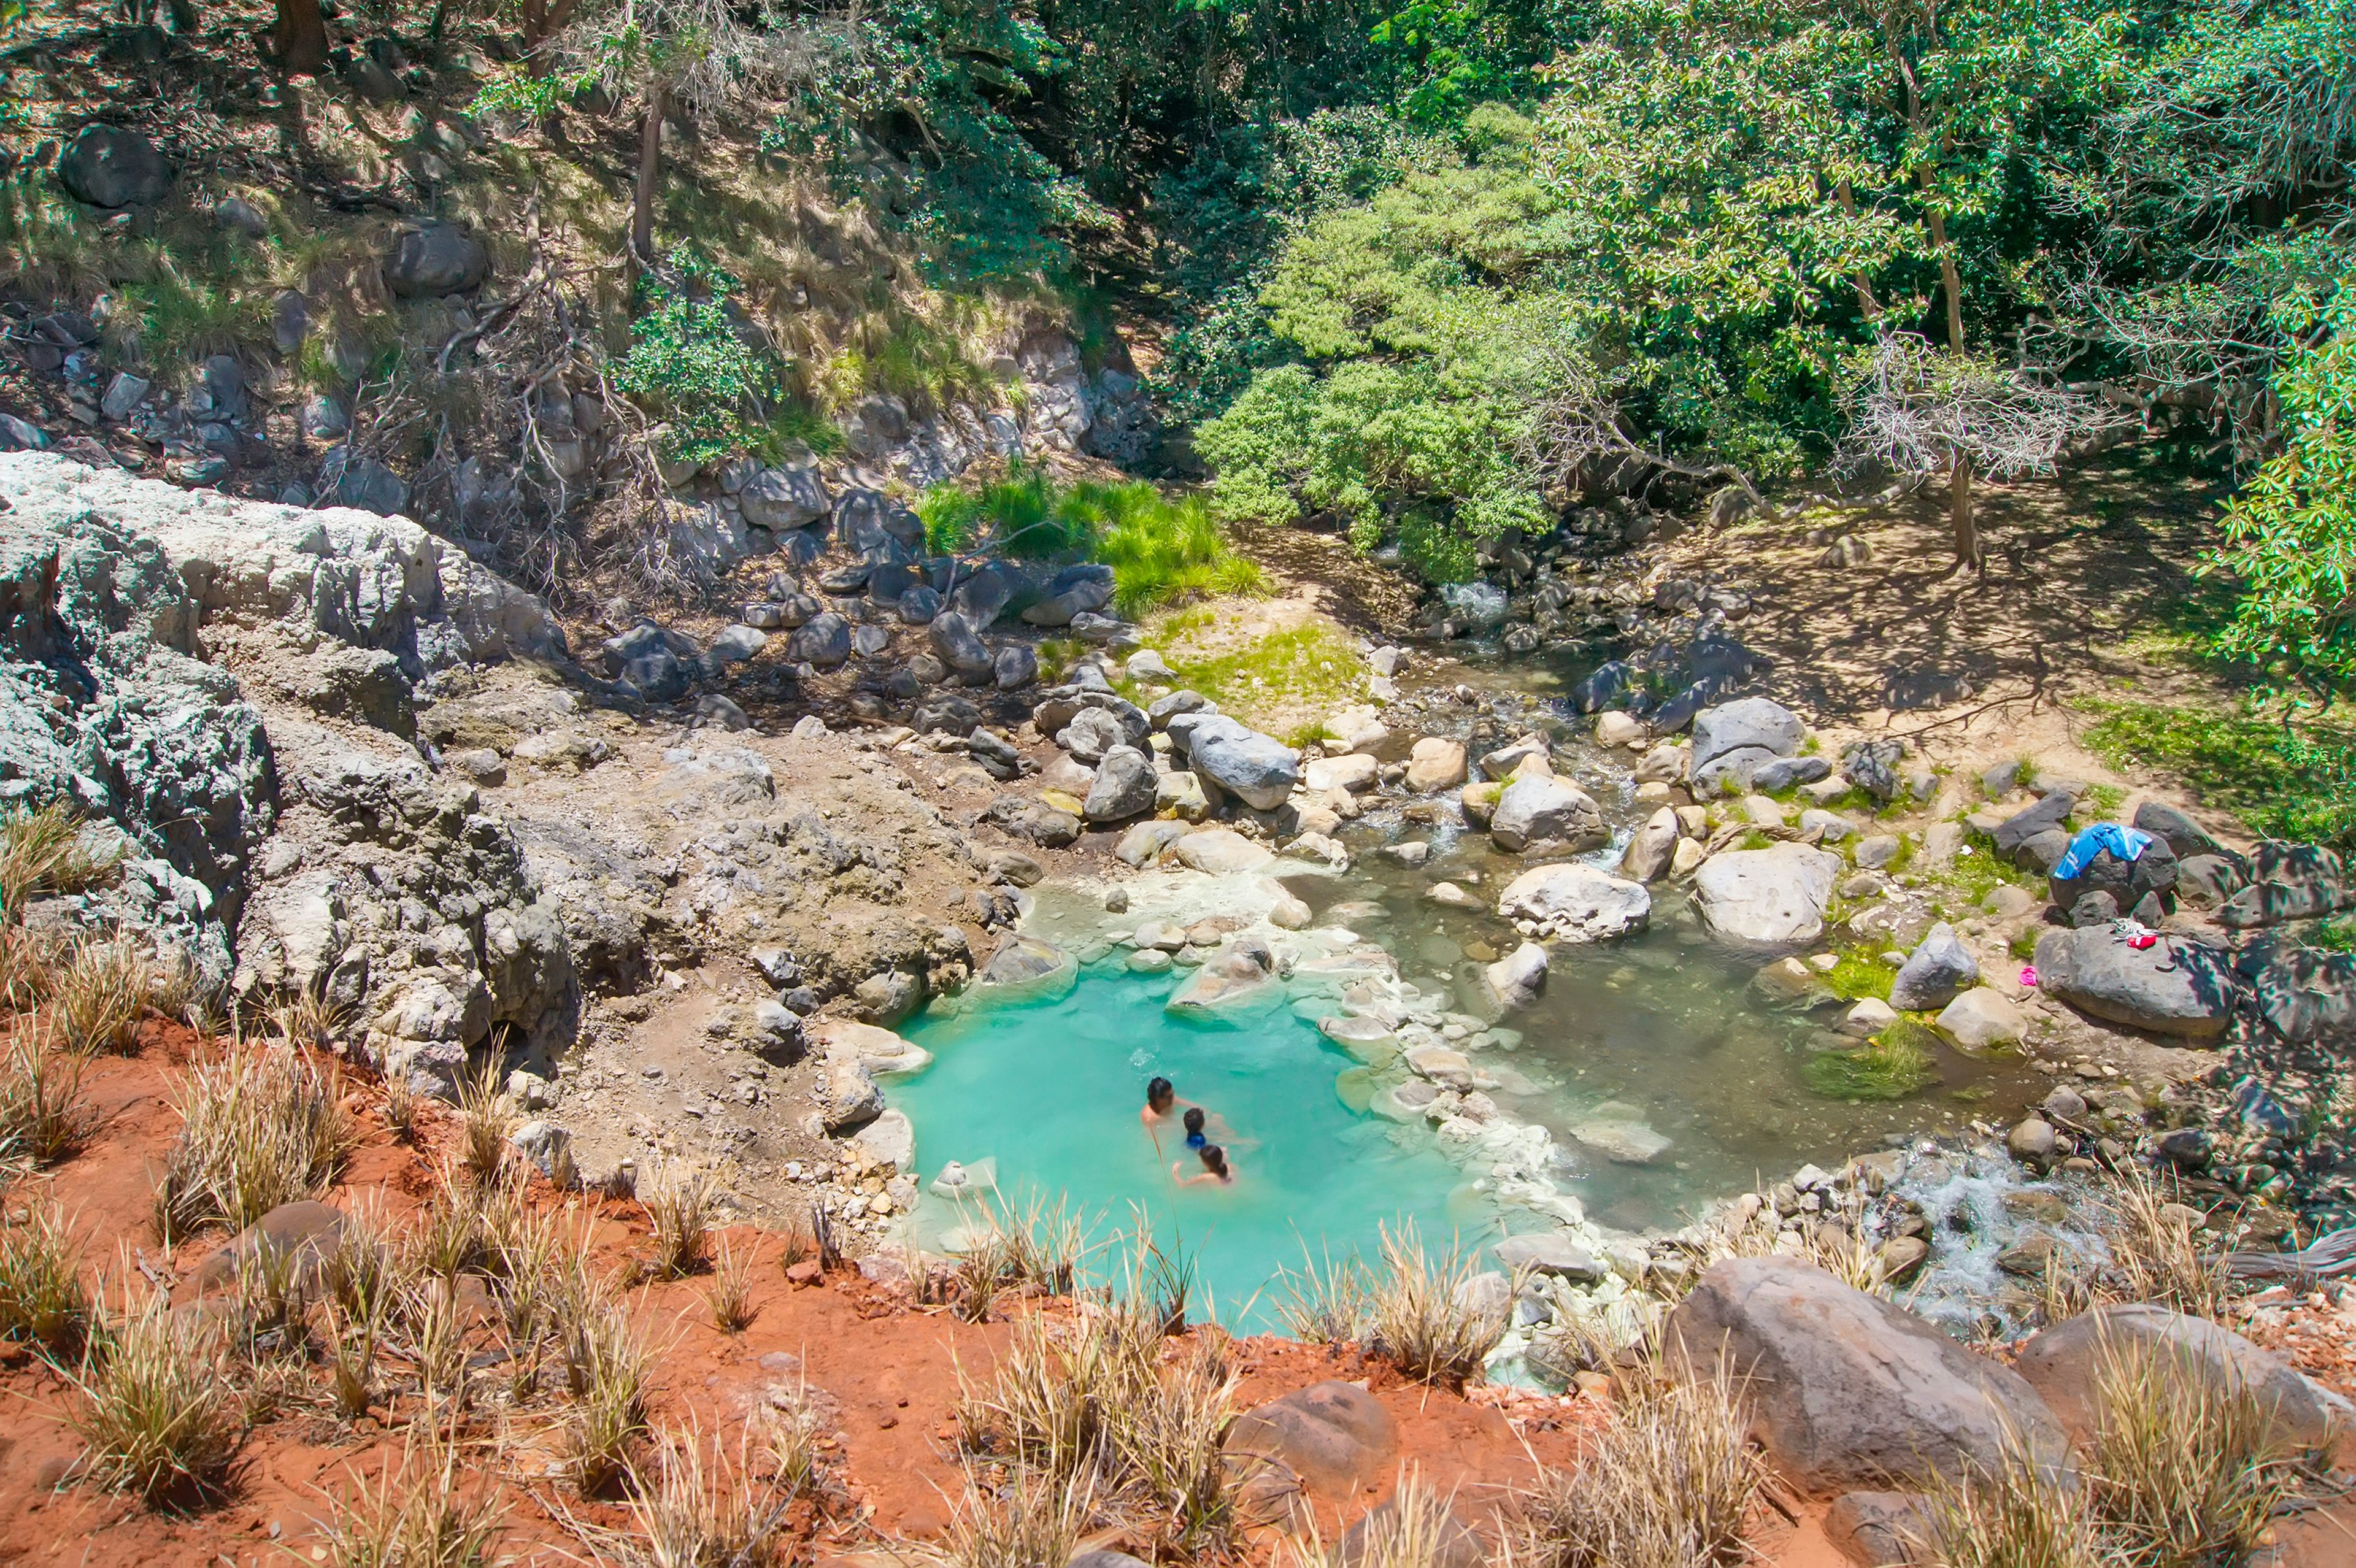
[917,466,1268,617]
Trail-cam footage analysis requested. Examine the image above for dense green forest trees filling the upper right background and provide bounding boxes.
[450,0,2356,631]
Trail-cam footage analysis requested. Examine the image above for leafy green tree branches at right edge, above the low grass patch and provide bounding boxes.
[2203,275,2356,699]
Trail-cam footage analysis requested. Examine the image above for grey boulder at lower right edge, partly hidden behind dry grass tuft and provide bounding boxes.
[2014,1302,2349,1453]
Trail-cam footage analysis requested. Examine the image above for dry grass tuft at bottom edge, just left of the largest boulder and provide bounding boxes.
[1510,1366,1765,1568]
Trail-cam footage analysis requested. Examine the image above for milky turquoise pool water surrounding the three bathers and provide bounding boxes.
[891,958,1496,1326]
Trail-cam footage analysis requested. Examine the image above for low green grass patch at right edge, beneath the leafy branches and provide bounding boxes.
[2085,702,2356,845]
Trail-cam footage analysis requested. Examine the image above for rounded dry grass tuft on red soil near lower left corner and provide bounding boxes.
[68,1299,245,1502]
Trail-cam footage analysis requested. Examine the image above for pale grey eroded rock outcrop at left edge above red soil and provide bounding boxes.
[0,452,563,989]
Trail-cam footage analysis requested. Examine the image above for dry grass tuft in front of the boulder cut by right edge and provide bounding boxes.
[2087,1342,2292,1568]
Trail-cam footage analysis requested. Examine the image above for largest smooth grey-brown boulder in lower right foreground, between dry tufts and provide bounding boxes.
[1663,1257,2069,1493]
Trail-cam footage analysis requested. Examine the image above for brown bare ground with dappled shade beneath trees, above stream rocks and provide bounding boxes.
[1675,452,2222,730]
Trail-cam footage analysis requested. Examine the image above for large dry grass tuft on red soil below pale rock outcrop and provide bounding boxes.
[155,1045,351,1239]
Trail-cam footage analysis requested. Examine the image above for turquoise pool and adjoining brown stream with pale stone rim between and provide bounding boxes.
[891,645,2050,1328]
